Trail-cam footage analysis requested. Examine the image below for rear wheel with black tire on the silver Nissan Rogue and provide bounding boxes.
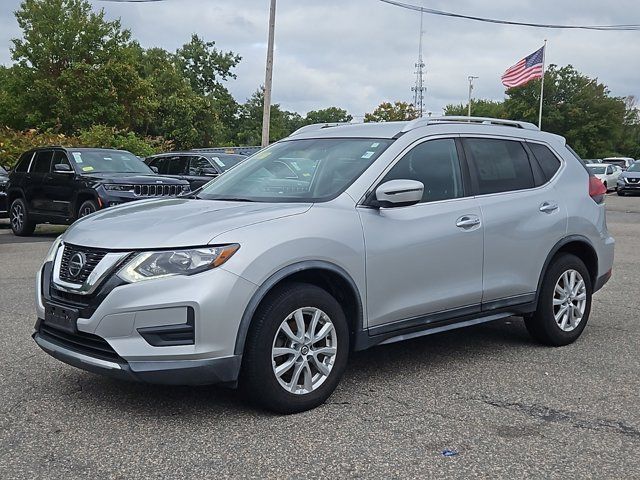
[524,254,593,347]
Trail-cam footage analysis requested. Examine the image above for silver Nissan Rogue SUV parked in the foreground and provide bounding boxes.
[33,117,614,413]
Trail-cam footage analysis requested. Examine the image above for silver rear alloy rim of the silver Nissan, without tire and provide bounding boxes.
[553,269,587,332]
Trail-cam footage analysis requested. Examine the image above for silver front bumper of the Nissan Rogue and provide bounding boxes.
[33,258,256,385]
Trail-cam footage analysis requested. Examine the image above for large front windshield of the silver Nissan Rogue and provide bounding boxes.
[198,138,393,202]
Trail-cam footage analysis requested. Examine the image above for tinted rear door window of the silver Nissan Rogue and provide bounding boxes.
[463,138,535,195]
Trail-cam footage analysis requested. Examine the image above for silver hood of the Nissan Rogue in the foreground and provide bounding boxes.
[63,198,311,250]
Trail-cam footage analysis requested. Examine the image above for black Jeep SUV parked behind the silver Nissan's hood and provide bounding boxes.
[7,147,190,236]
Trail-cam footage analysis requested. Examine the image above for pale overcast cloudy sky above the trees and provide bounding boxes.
[0,0,640,116]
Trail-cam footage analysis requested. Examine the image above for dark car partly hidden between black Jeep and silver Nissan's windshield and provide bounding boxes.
[145,151,247,190]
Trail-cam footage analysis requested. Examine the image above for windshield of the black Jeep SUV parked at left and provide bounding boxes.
[71,149,153,175]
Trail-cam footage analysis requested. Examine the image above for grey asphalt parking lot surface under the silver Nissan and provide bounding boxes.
[0,195,640,479]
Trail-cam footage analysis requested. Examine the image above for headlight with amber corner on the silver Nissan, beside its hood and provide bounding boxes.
[118,244,240,283]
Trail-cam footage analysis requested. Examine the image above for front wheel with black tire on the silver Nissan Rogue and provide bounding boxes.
[240,283,350,414]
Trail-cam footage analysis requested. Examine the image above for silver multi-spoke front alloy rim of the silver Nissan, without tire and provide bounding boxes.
[271,307,338,395]
